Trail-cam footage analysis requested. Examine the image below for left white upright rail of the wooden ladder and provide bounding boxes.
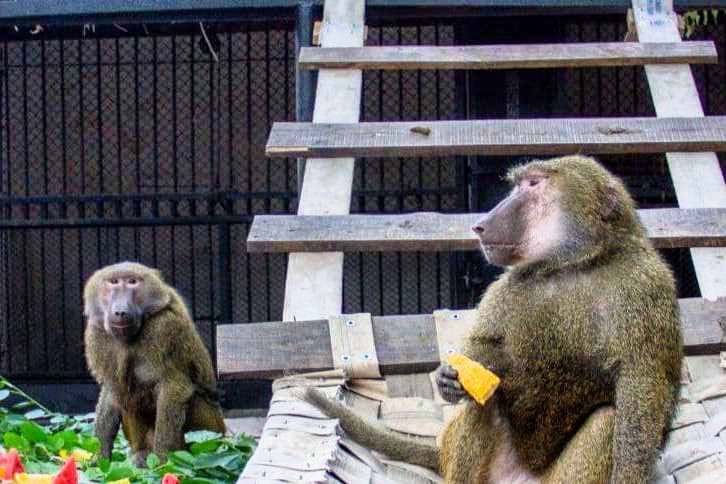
[283,0,365,321]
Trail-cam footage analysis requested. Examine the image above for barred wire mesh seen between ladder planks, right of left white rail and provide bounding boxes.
[344,24,460,314]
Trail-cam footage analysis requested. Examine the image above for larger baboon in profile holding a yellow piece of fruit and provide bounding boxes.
[302,156,683,484]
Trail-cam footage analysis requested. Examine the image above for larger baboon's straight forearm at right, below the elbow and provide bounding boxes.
[610,367,673,484]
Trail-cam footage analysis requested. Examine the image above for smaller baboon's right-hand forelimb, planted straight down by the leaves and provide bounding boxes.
[154,373,194,457]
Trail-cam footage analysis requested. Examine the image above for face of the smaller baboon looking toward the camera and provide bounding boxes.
[99,272,146,341]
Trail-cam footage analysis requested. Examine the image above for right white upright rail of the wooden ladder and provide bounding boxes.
[632,0,726,298]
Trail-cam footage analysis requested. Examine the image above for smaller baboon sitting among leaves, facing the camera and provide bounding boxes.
[83,262,225,466]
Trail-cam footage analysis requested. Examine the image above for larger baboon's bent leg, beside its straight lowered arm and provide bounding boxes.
[542,407,615,484]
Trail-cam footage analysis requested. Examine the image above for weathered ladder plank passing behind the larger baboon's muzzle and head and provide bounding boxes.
[247,208,726,252]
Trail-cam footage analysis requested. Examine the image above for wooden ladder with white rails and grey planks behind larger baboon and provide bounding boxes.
[218,0,726,377]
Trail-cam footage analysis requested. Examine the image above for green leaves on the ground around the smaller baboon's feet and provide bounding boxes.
[0,376,256,484]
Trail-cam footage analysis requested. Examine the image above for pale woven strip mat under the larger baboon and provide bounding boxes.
[238,356,726,484]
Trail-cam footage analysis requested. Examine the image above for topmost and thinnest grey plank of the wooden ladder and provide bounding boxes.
[299,42,718,70]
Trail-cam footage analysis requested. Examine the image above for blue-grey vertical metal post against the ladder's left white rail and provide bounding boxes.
[295,0,315,193]
